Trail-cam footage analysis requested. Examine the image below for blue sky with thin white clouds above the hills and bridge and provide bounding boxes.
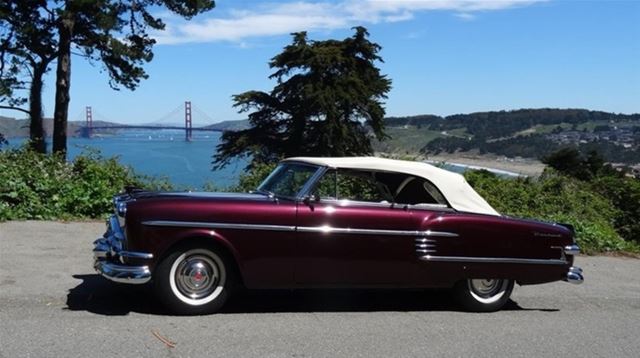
[0,0,640,125]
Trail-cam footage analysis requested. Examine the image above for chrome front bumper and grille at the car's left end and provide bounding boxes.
[93,215,153,284]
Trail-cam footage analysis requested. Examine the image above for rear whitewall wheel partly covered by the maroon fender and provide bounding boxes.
[453,279,514,312]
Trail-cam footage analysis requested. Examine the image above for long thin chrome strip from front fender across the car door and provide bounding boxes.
[142,220,459,237]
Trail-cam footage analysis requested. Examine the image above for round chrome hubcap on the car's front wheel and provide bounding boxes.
[175,255,220,300]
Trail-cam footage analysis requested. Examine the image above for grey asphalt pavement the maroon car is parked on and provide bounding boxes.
[0,222,640,357]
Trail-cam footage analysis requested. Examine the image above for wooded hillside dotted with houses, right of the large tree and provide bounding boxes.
[375,108,640,164]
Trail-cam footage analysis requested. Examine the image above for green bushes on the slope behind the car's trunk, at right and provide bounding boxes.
[465,170,639,253]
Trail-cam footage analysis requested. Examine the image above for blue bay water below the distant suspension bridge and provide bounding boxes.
[9,130,247,189]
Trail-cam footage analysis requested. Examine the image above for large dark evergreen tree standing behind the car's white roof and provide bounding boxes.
[214,27,391,167]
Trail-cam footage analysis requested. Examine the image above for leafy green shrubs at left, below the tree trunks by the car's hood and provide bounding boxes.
[0,149,170,220]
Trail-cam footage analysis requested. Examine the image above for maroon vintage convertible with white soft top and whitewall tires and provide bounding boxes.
[93,157,583,314]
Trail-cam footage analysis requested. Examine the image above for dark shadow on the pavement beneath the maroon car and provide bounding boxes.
[67,274,557,316]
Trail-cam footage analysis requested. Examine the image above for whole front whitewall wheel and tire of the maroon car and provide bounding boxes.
[155,245,235,314]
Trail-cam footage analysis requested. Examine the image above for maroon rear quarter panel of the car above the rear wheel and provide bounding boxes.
[414,212,574,286]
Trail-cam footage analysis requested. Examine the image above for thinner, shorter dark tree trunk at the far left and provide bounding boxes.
[29,63,47,153]
